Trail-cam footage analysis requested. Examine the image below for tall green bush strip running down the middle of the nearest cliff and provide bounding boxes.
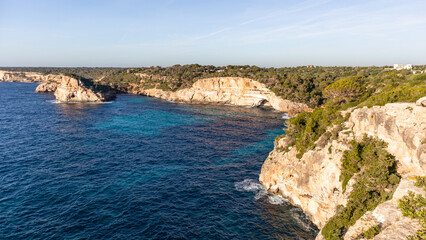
[321,136,400,239]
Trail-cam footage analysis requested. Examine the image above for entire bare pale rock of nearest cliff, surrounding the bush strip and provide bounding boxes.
[259,100,426,239]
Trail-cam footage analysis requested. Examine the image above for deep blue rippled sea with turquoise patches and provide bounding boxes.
[0,83,317,239]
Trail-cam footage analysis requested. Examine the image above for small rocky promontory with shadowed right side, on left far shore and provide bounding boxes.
[54,76,115,102]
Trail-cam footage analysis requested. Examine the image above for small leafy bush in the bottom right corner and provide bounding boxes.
[398,177,426,240]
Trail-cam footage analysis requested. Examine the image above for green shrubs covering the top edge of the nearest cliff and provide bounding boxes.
[286,72,426,158]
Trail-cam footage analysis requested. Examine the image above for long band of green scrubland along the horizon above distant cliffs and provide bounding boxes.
[2,64,426,108]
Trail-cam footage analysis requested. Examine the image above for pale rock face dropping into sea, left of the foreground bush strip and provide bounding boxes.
[259,124,351,228]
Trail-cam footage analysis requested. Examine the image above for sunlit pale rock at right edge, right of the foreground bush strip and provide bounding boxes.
[349,103,426,176]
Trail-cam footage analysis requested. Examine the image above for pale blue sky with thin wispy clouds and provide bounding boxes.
[0,0,426,67]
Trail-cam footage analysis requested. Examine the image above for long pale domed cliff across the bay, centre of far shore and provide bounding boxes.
[137,77,309,114]
